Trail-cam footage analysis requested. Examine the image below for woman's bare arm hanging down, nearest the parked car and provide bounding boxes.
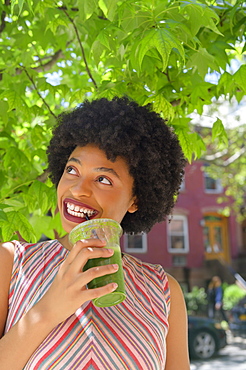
[165,275,190,370]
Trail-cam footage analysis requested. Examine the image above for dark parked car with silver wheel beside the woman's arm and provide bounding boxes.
[188,316,227,360]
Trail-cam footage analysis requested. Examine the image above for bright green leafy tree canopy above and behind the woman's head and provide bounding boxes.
[0,0,246,241]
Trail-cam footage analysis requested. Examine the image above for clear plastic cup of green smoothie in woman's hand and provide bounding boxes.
[69,218,126,307]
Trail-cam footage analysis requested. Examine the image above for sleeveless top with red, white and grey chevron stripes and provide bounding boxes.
[5,240,170,370]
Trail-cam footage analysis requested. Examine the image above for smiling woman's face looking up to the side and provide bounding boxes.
[57,144,137,232]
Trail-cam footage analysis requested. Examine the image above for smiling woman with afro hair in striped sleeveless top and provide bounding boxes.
[0,98,189,370]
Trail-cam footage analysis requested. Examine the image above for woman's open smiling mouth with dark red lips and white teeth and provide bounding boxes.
[63,198,99,223]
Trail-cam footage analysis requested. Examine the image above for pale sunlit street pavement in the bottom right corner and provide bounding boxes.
[190,334,246,370]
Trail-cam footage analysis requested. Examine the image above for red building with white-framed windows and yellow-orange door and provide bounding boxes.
[122,161,246,289]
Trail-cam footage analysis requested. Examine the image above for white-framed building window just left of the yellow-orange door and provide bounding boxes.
[167,215,189,253]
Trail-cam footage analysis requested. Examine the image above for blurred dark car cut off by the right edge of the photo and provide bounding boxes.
[229,296,246,338]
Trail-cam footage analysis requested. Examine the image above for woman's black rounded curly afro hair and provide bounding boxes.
[47,97,186,233]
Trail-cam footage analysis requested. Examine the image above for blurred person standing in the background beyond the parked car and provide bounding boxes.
[207,276,228,321]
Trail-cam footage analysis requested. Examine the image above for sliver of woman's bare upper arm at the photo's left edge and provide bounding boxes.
[0,242,14,337]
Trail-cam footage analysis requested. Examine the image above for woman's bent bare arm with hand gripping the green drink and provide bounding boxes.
[0,239,119,370]
